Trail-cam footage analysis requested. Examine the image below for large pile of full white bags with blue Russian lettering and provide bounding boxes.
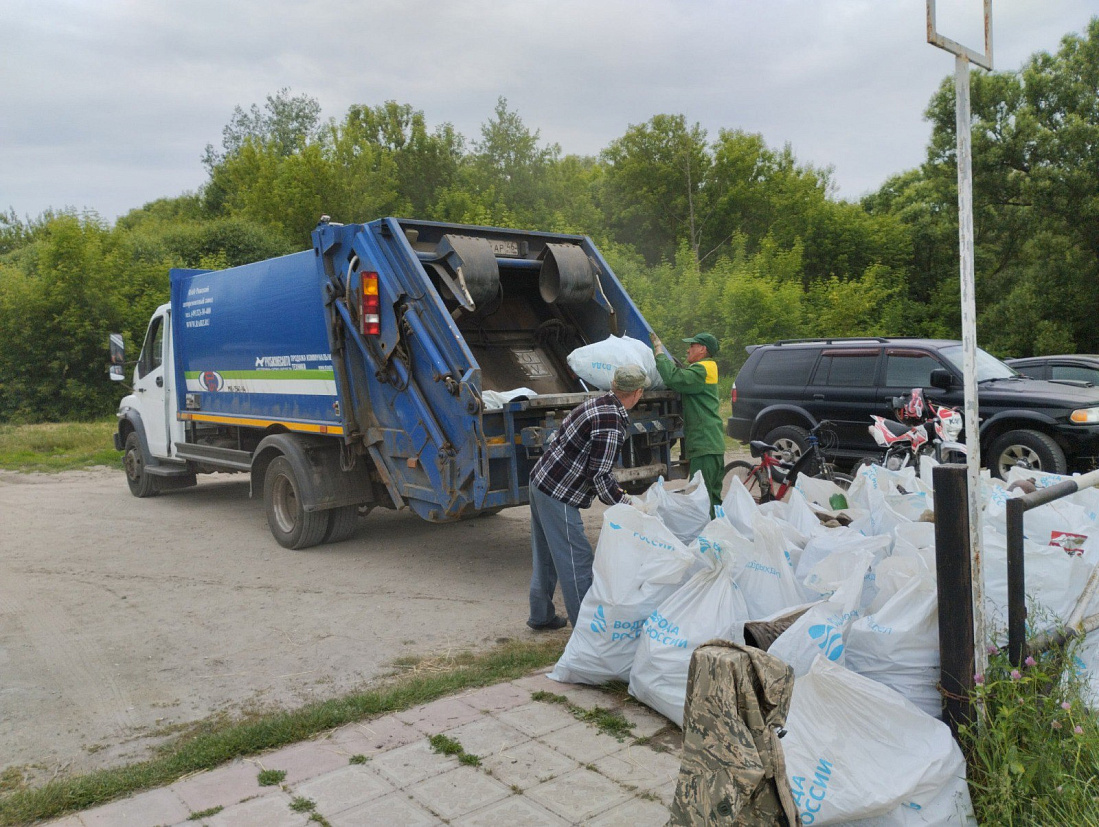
[551,466,1099,825]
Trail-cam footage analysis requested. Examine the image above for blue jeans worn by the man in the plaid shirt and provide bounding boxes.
[530,485,592,627]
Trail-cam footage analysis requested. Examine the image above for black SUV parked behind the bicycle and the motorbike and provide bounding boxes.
[725,338,1099,477]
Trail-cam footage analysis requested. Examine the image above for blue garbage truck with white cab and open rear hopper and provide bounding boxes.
[112,217,682,548]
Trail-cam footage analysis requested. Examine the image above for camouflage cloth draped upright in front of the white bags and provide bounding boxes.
[668,640,800,827]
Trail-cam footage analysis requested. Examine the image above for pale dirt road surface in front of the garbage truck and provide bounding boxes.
[0,469,602,779]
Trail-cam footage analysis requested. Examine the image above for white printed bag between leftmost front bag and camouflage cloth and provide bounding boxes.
[630,549,747,727]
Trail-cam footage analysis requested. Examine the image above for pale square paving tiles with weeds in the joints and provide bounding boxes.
[52,670,682,827]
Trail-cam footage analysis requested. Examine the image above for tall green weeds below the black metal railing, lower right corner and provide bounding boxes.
[959,649,1099,827]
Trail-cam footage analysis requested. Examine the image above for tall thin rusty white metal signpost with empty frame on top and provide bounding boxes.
[928,0,992,685]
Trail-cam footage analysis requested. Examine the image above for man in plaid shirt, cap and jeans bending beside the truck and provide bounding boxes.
[526,365,648,632]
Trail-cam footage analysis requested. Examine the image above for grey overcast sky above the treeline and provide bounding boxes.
[0,0,1099,221]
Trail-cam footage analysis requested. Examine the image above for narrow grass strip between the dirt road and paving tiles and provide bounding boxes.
[0,636,565,827]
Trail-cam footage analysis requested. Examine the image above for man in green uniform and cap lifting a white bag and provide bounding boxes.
[652,333,725,505]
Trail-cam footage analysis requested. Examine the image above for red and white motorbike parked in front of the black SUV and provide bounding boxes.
[869,388,966,471]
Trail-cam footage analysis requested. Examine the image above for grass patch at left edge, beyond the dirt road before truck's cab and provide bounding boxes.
[0,418,122,472]
